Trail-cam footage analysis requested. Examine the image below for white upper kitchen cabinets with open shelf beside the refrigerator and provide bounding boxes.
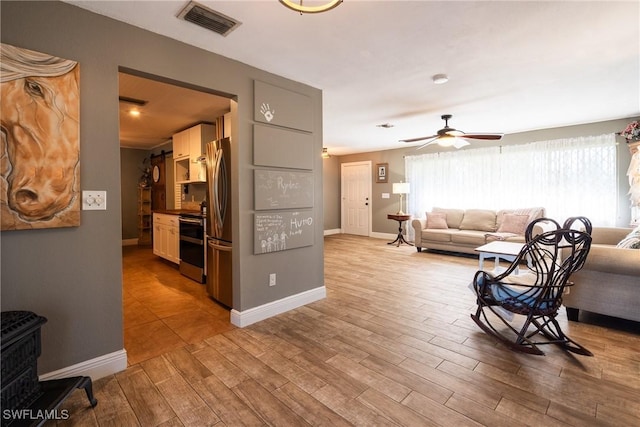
[173,124,215,184]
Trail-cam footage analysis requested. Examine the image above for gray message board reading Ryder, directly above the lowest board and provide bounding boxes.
[254,169,313,211]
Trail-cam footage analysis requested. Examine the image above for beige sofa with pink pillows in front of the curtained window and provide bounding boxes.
[411,207,545,255]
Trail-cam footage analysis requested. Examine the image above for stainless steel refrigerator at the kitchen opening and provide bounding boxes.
[206,138,233,308]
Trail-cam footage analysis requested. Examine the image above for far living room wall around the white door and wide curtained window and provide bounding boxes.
[324,117,640,234]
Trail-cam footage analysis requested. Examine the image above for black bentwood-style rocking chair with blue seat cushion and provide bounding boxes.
[471,217,593,356]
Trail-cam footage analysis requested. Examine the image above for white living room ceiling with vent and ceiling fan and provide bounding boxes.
[67,0,640,154]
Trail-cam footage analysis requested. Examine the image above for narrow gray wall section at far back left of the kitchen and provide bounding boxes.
[120,148,150,240]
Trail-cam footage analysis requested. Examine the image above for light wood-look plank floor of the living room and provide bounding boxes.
[60,235,640,427]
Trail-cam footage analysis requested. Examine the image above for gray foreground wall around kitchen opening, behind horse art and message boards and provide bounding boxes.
[1,1,324,373]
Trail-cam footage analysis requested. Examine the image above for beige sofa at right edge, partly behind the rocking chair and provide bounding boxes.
[563,227,640,322]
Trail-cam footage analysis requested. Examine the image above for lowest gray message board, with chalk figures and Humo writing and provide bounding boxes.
[253,209,314,254]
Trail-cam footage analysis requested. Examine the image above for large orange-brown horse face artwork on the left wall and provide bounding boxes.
[0,43,81,230]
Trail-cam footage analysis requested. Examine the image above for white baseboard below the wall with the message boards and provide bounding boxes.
[231,286,327,328]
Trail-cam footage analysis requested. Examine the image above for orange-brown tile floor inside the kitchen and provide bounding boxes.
[122,246,235,366]
